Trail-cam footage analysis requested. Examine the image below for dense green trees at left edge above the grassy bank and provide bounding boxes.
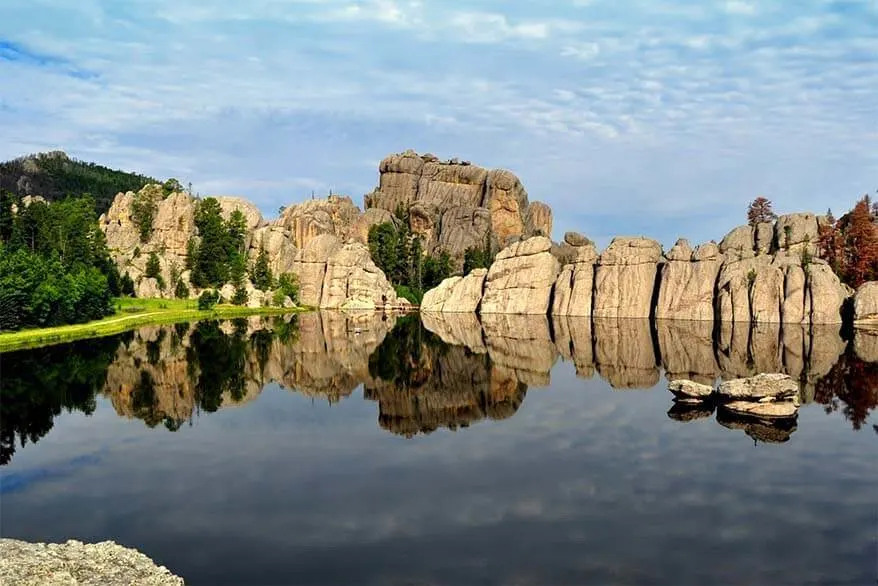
[0,191,122,330]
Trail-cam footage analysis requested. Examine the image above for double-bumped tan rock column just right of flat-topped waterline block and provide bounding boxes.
[655,239,723,321]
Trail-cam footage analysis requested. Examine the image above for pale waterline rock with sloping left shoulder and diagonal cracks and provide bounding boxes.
[481,236,560,315]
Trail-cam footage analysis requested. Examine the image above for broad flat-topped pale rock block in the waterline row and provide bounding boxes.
[593,237,662,318]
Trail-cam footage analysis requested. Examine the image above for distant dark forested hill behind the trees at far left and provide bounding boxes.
[0,151,161,214]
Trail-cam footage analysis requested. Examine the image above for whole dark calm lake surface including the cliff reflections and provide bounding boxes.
[0,314,878,584]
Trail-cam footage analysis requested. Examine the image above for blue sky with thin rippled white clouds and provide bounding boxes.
[0,0,878,248]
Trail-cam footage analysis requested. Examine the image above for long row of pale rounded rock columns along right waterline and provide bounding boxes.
[423,214,874,325]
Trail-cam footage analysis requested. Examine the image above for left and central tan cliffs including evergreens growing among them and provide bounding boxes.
[94,151,552,309]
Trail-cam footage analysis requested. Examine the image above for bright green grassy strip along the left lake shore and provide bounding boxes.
[0,297,309,352]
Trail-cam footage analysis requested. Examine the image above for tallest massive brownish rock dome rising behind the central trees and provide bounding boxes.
[365,151,552,268]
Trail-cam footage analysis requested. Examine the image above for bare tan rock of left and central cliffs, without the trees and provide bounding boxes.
[100,151,552,309]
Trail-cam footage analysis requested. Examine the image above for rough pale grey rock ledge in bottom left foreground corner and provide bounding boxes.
[0,539,183,586]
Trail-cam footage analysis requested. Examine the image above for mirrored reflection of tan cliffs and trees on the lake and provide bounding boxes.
[0,312,878,464]
